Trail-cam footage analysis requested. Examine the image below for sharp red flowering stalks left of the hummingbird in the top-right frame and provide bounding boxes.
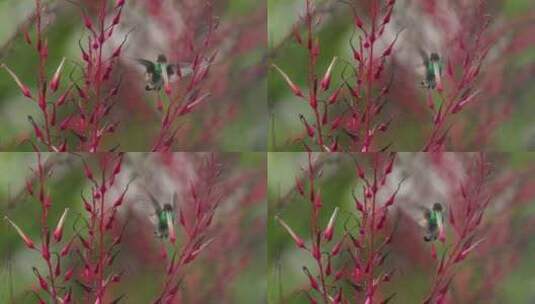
[273,0,397,152]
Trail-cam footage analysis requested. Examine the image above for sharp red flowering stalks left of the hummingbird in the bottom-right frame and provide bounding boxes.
[276,153,399,303]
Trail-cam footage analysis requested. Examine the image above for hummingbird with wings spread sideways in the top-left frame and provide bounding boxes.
[137,54,193,91]
